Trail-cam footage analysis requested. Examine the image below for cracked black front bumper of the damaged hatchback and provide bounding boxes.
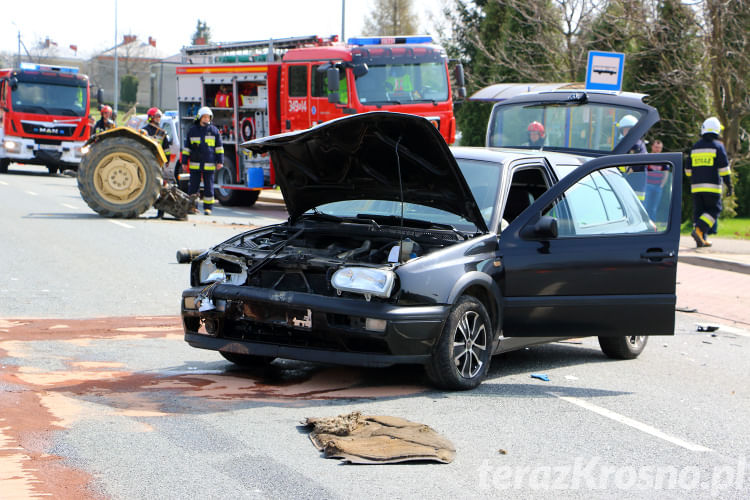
[181,285,450,366]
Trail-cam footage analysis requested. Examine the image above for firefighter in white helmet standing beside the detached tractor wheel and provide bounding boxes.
[182,106,224,215]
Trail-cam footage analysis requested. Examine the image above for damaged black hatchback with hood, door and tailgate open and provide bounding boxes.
[182,92,682,389]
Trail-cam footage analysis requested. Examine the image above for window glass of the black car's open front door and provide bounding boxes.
[545,165,672,238]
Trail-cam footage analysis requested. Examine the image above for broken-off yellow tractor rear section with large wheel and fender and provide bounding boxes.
[78,117,194,219]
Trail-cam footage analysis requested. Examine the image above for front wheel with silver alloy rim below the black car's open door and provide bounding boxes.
[425,295,493,391]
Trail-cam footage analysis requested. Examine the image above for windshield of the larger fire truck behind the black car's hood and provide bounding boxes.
[356,61,448,104]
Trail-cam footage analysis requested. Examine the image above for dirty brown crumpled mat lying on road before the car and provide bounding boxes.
[302,411,456,464]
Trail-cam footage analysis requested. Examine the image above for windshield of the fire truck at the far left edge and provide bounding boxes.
[11,81,88,116]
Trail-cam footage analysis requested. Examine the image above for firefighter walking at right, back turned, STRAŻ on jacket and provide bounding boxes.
[685,116,734,248]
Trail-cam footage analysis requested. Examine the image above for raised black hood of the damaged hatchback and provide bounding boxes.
[242,111,487,232]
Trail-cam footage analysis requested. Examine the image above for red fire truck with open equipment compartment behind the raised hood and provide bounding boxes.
[177,36,466,205]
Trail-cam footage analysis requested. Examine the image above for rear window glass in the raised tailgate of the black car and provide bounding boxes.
[488,102,643,153]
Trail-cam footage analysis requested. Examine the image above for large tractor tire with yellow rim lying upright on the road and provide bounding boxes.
[78,136,162,219]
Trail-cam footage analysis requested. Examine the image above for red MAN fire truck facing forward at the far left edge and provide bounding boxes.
[0,63,90,173]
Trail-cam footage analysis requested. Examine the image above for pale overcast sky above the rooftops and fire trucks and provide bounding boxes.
[0,0,443,57]
